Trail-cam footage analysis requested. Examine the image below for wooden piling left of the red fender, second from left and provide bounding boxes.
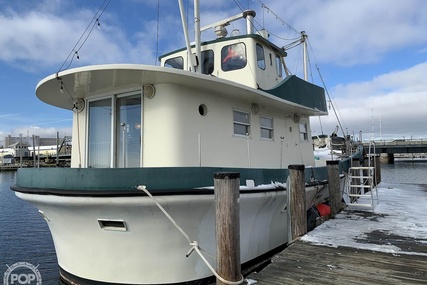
[287,165,307,241]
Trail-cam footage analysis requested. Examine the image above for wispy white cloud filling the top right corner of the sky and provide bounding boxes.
[263,0,427,66]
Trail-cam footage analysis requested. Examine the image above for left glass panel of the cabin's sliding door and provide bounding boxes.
[88,99,112,168]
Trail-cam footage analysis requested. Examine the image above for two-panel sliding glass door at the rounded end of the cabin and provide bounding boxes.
[87,93,142,168]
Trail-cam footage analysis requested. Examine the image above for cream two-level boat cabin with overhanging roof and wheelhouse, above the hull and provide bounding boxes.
[36,11,327,171]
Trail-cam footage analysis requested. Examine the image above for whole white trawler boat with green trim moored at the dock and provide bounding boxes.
[12,2,362,284]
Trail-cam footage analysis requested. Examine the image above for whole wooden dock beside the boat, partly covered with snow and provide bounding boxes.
[248,184,427,285]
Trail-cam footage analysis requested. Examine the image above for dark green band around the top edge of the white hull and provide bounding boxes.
[12,167,326,191]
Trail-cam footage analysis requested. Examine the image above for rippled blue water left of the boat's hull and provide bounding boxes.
[0,171,59,285]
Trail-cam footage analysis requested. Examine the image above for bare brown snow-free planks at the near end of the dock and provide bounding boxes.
[249,241,427,285]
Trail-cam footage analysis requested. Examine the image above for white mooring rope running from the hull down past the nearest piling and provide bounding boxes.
[136,185,244,285]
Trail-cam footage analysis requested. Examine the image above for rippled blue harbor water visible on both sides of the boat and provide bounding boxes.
[0,160,427,285]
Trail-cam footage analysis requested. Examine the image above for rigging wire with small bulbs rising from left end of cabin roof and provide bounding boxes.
[56,0,111,73]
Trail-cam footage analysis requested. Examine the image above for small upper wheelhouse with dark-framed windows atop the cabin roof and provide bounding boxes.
[160,10,286,89]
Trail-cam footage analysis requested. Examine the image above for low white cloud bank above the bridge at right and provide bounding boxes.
[312,62,427,137]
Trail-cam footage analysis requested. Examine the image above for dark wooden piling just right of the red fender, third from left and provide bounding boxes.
[326,160,342,217]
